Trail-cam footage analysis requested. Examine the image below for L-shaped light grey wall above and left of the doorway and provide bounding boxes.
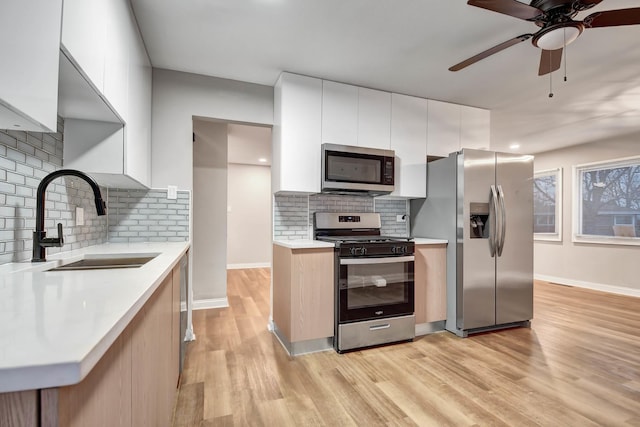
[151,68,273,190]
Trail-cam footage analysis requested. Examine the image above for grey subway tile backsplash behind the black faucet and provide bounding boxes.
[0,118,190,264]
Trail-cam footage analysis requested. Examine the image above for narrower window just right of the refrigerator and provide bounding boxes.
[533,169,562,241]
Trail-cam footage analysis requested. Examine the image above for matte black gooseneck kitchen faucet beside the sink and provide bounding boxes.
[31,169,107,262]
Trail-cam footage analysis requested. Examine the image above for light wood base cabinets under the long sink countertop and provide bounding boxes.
[0,255,186,427]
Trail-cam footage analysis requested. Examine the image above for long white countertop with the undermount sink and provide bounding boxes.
[0,242,189,392]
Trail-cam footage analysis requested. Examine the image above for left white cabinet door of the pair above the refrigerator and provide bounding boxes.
[427,100,461,157]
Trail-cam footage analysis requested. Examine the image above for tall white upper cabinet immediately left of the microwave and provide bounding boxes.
[271,73,322,193]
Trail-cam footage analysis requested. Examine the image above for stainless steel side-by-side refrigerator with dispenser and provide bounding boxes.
[410,149,533,337]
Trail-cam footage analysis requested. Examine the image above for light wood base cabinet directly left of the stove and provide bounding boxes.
[273,245,334,343]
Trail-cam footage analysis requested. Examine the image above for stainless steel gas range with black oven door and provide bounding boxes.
[314,212,415,353]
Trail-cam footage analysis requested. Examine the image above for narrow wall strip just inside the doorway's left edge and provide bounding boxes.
[191,120,227,306]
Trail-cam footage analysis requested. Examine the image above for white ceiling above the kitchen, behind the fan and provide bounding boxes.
[132,0,640,153]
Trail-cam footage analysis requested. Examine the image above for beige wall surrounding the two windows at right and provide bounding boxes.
[534,134,640,296]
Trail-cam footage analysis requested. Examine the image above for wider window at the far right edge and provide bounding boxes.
[573,157,640,245]
